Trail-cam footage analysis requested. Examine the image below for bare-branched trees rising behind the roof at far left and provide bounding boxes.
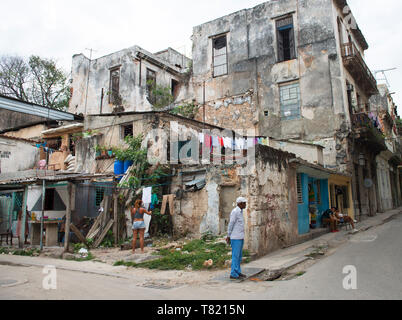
[0,55,70,110]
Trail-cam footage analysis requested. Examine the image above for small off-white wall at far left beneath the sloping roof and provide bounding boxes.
[0,137,39,173]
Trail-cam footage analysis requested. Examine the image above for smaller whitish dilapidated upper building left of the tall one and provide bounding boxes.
[69,46,191,115]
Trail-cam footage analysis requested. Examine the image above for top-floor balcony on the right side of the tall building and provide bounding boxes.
[342,42,378,97]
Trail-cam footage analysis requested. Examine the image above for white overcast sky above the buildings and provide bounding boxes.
[0,0,402,114]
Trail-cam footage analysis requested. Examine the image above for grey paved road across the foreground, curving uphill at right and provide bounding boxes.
[0,215,402,300]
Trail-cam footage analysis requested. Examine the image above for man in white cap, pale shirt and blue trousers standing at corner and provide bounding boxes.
[226,197,247,279]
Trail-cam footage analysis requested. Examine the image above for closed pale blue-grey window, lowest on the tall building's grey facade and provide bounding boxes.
[279,83,300,120]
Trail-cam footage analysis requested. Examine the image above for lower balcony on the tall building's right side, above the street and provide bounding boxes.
[351,113,388,154]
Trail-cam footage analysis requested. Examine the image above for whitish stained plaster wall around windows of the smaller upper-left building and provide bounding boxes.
[69,46,185,114]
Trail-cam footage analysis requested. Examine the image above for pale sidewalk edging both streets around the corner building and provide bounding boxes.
[0,207,402,284]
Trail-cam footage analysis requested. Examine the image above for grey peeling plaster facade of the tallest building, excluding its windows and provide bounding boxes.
[193,0,350,170]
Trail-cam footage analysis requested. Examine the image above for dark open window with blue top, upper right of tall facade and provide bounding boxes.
[276,17,296,62]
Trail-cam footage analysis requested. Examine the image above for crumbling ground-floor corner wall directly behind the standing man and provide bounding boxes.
[172,146,297,255]
